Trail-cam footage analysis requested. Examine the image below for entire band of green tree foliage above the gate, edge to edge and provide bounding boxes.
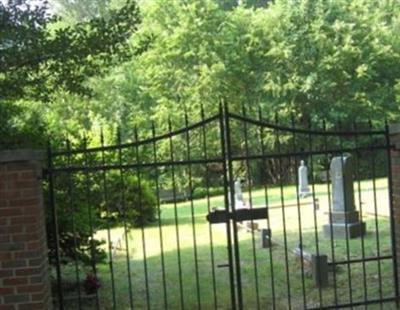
[0,0,400,147]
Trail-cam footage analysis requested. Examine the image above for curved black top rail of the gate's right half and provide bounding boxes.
[228,112,386,136]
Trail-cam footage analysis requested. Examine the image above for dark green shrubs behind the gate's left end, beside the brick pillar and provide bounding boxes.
[46,167,157,265]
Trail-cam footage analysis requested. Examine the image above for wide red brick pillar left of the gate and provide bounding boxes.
[0,150,52,310]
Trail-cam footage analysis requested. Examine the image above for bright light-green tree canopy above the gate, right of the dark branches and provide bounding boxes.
[87,0,400,134]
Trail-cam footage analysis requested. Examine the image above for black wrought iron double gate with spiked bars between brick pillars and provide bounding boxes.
[46,106,399,309]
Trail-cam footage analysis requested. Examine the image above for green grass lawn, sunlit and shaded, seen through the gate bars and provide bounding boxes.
[56,179,394,309]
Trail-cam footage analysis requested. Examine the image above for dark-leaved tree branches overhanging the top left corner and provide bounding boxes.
[0,0,140,101]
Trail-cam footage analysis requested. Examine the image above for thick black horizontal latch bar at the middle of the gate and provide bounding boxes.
[206,207,268,224]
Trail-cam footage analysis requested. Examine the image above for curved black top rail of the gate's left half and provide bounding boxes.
[52,113,221,157]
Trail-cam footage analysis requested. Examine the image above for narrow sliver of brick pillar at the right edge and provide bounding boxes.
[389,124,400,286]
